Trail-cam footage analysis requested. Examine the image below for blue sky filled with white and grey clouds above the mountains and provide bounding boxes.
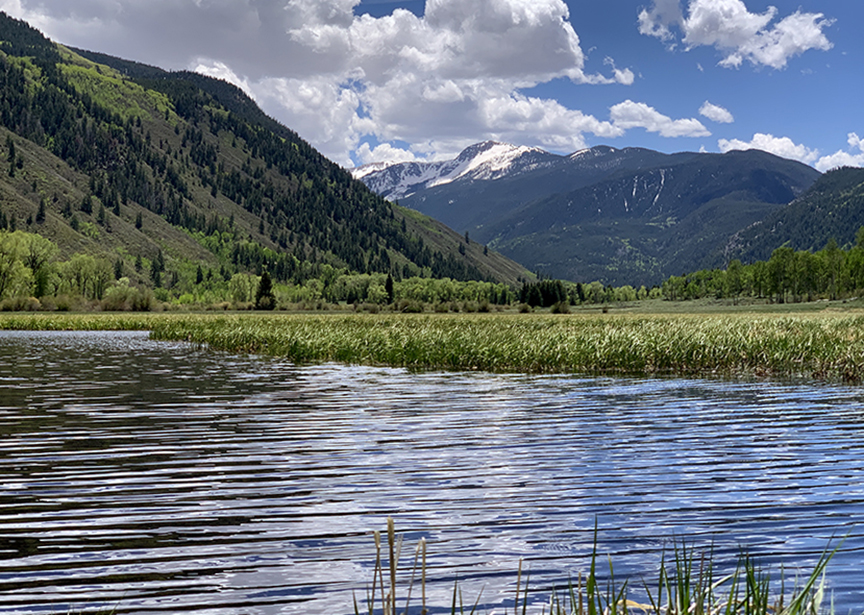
[0,0,864,170]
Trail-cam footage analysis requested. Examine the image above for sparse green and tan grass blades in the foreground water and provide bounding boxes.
[366,518,839,615]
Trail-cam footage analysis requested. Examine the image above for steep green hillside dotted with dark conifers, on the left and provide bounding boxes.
[0,13,529,310]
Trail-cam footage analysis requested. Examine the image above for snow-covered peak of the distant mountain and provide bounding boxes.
[351,141,562,201]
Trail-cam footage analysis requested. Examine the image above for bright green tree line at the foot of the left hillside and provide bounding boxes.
[0,229,517,310]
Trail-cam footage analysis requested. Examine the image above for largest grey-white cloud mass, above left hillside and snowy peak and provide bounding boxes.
[0,0,652,165]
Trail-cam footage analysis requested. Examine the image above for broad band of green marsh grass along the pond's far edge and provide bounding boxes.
[0,311,864,382]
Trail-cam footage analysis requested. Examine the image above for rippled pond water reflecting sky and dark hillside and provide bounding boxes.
[0,333,864,615]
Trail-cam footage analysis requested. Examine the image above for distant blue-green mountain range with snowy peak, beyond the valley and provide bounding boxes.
[352,142,820,285]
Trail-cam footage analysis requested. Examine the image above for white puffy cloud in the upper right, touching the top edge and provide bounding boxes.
[639,0,833,69]
